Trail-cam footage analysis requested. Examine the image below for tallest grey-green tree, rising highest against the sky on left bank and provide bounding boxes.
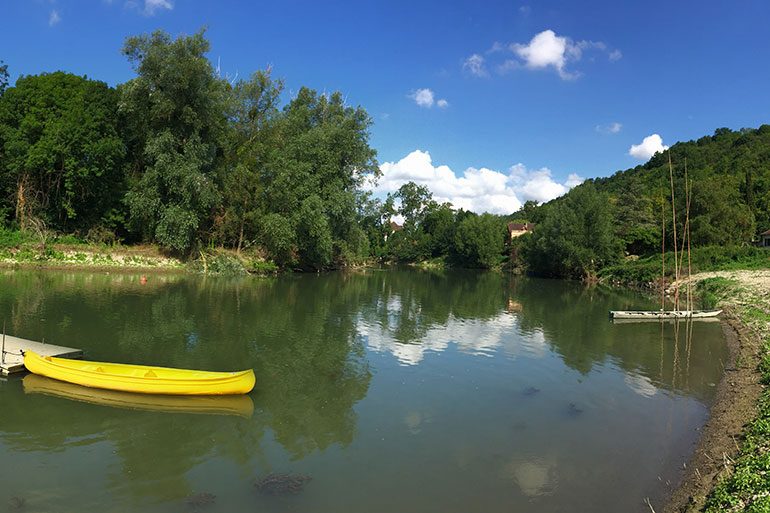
[120,31,225,253]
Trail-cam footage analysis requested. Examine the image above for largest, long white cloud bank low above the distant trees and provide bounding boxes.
[367,150,583,214]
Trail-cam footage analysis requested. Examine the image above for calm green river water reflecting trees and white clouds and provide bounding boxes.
[0,271,727,513]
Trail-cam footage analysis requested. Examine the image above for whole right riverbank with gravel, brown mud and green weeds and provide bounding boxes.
[663,270,770,513]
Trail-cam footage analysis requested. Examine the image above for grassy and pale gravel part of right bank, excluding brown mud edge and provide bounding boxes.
[687,271,770,513]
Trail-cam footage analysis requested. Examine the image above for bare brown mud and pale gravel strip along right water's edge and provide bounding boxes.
[663,270,770,513]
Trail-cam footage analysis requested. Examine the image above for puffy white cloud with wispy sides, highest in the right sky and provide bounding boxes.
[463,29,623,80]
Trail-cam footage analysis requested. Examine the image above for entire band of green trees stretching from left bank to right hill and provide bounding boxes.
[0,31,770,278]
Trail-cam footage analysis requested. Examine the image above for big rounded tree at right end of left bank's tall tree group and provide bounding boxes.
[259,88,380,269]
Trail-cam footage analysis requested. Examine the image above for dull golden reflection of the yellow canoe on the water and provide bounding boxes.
[23,374,254,418]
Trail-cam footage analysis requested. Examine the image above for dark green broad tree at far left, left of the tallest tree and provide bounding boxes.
[0,72,126,231]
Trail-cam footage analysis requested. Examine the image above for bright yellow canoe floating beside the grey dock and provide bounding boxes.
[24,351,256,395]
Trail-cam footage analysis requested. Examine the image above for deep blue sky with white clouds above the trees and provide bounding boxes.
[0,0,770,213]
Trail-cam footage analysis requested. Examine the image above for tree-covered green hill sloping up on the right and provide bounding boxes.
[515,125,770,277]
